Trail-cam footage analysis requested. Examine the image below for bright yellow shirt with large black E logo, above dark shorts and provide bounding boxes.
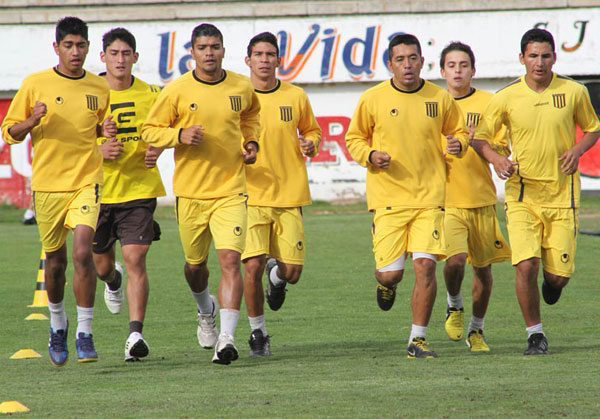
[99,78,166,204]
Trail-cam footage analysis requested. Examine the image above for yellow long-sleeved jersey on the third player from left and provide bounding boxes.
[142,71,260,199]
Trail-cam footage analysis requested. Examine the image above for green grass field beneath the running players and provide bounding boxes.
[0,196,600,417]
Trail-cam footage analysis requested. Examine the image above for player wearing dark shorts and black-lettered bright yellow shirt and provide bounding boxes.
[93,28,165,361]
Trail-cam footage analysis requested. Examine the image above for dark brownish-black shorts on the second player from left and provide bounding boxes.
[93,198,160,253]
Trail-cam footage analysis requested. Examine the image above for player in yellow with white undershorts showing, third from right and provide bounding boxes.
[346,34,469,358]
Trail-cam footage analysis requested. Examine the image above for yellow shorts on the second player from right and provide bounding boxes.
[444,205,510,268]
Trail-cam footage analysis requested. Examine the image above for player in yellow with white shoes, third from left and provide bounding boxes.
[142,23,260,364]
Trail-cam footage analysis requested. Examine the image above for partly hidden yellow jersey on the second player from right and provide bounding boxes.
[442,90,508,208]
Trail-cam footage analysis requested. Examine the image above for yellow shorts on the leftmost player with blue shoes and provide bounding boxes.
[33,184,102,252]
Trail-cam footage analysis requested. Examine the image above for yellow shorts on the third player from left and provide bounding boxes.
[175,194,247,265]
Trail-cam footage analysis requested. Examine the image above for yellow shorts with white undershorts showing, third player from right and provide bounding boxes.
[373,207,446,269]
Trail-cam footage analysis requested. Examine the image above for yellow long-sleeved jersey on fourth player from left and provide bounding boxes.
[246,80,321,208]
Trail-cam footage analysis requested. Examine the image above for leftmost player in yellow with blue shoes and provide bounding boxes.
[2,17,116,366]
